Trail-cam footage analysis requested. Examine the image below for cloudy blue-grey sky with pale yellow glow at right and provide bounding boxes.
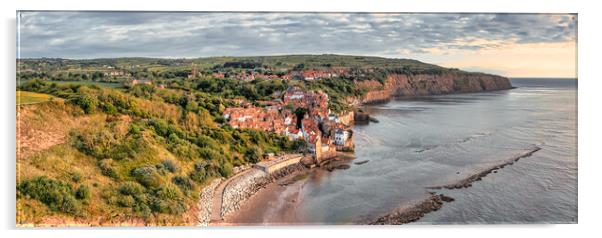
[17,11,577,77]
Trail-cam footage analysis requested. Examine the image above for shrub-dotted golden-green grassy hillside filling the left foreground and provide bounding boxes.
[17,82,291,226]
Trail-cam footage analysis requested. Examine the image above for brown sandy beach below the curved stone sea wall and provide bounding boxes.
[209,153,355,226]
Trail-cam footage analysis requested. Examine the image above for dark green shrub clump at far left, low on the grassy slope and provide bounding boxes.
[17,176,81,215]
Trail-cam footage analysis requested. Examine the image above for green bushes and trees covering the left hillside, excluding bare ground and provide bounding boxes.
[18,80,300,223]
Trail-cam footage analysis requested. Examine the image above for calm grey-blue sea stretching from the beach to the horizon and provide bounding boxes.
[227,79,577,224]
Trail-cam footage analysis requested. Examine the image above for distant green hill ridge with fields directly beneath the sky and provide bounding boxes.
[19,54,468,75]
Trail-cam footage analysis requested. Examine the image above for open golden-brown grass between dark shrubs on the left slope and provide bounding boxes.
[17,102,204,226]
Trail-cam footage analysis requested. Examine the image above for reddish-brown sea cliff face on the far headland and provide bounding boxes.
[357,73,512,103]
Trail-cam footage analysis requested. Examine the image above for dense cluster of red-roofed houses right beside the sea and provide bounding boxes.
[223,87,354,162]
